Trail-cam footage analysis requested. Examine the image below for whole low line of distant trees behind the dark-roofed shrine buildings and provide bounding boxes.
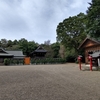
[0,38,60,58]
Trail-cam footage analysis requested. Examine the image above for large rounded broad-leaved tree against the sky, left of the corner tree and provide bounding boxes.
[56,13,86,54]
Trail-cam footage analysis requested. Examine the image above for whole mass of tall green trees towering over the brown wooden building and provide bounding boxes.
[56,0,100,61]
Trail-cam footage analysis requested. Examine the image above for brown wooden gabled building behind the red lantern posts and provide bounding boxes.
[78,38,100,66]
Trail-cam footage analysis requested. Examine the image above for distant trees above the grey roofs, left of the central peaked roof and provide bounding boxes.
[0,38,39,56]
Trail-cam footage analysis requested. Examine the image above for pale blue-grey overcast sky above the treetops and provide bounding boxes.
[0,0,91,43]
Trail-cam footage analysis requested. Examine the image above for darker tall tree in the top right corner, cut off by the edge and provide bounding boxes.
[87,0,100,38]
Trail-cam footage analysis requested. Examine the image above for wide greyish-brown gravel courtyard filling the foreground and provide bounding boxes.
[0,64,100,100]
